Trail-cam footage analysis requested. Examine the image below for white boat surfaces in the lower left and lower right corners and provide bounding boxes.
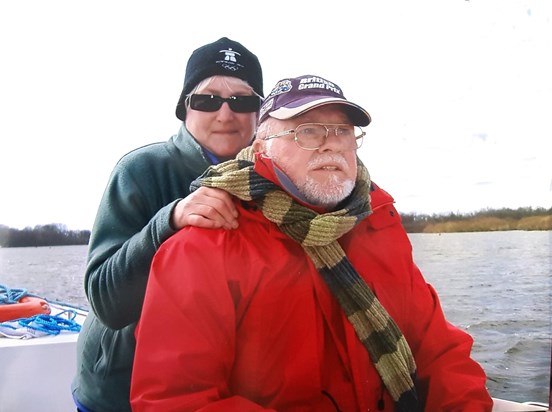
[0,302,549,412]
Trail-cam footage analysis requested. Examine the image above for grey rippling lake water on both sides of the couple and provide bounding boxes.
[0,231,552,402]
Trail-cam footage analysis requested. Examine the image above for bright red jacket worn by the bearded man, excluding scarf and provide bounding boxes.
[131,179,492,412]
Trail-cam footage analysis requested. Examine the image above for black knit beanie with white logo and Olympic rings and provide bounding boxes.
[176,37,264,121]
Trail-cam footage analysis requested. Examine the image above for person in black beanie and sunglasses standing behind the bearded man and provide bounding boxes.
[71,37,263,412]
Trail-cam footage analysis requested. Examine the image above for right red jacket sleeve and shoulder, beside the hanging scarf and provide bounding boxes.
[357,192,492,412]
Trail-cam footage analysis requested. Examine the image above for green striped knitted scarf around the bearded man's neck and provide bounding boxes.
[191,148,418,411]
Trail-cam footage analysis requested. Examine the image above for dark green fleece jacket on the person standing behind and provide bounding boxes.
[71,124,215,412]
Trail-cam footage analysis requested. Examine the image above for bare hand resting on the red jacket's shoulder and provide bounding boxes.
[171,187,238,230]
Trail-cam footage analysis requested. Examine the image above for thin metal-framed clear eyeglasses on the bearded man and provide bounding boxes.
[261,123,366,150]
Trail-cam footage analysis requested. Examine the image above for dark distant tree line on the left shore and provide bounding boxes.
[0,223,90,247]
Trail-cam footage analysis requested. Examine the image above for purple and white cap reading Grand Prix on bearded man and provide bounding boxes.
[259,75,372,126]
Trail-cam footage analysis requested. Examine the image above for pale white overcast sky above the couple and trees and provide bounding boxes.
[0,0,552,230]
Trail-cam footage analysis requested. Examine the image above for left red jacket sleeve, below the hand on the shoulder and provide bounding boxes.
[130,228,276,412]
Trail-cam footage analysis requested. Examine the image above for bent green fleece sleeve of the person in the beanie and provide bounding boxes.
[85,164,178,329]
